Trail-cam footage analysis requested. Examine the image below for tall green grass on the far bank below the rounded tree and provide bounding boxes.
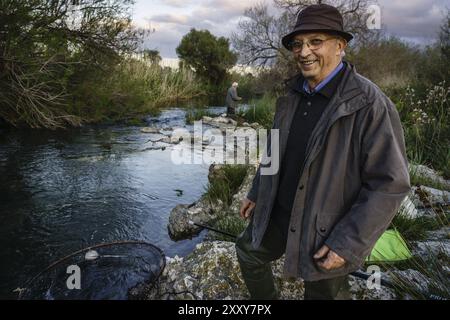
[70,58,205,121]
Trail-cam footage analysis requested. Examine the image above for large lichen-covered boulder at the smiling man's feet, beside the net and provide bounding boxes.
[135,241,303,300]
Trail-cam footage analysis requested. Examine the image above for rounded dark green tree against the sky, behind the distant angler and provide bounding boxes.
[176,29,237,85]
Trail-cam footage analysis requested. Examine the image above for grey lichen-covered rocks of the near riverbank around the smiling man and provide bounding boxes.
[130,114,450,300]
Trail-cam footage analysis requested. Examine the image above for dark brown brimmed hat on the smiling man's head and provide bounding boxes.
[281,4,353,49]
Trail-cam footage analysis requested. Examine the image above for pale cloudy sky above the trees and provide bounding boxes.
[132,0,450,58]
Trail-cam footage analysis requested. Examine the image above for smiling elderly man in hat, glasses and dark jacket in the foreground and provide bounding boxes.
[236,4,410,299]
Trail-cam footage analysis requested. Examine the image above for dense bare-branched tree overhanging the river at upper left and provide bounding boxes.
[0,0,142,128]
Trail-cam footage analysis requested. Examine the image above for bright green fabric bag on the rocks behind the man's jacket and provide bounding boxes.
[366,229,412,263]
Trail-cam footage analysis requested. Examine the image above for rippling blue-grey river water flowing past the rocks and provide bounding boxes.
[0,107,232,299]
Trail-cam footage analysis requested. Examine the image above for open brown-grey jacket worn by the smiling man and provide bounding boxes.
[247,63,410,281]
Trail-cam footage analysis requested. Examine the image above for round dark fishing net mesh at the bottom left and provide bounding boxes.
[19,241,165,300]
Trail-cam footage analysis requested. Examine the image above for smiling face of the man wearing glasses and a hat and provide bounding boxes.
[292,33,346,85]
